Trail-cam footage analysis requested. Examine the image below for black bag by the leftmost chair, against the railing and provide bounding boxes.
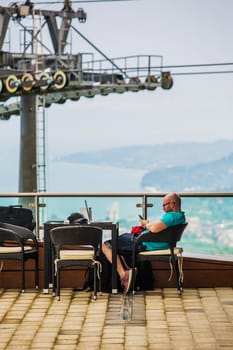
[0,205,35,231]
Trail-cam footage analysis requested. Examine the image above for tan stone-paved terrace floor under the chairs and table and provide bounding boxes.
[0,288,233,350]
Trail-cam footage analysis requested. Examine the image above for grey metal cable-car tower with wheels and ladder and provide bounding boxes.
[0,0,173,192]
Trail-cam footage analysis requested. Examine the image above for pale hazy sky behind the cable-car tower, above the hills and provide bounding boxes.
[0,0,233,158]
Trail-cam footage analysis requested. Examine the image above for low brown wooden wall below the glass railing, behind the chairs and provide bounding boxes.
[0,242,233,290]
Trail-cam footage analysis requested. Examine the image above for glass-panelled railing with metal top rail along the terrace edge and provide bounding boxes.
[0,192,233,259]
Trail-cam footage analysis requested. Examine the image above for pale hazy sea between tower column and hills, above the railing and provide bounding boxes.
[47,162,145,193]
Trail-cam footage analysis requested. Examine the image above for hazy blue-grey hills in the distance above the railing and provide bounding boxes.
[56,140,233,192]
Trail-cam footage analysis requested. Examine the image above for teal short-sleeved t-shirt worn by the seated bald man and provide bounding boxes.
[142,211,186,250]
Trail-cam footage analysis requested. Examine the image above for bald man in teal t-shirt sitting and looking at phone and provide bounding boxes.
[102,193,186,293]
